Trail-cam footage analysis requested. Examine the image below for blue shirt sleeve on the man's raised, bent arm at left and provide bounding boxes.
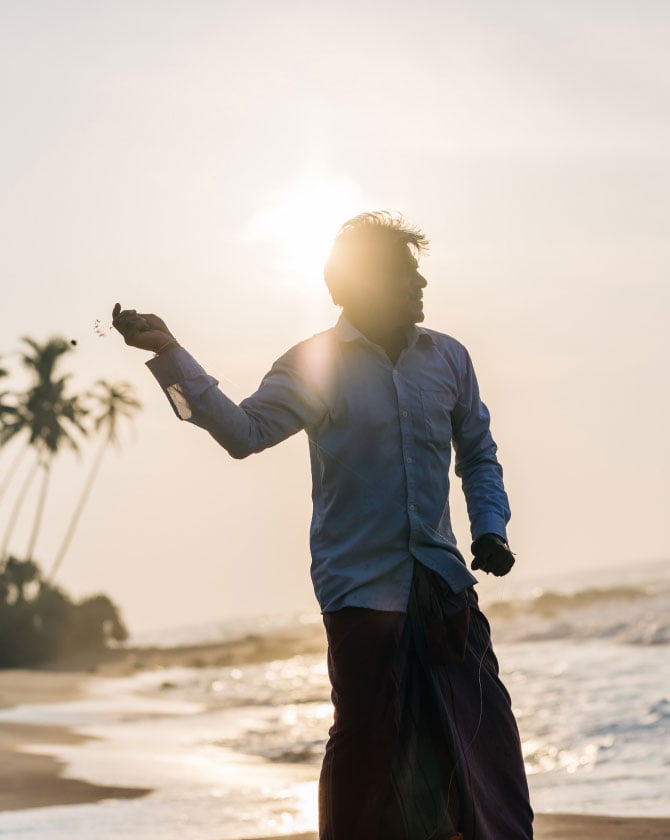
[147,347,325,458]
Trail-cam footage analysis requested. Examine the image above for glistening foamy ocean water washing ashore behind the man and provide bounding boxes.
[0,567,670,840]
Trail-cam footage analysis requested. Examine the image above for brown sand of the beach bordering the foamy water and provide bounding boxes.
[0,656,670,840]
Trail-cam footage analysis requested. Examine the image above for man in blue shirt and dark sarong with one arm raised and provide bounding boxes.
[113,213,533,840]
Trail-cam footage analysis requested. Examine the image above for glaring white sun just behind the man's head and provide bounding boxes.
[248,178,362,290]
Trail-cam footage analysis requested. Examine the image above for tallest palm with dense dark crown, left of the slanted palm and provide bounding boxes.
[0,337,87,558]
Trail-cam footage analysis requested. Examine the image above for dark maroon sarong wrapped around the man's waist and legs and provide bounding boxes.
[319,562,533,840]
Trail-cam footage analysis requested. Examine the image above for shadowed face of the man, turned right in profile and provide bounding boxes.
[345,242,427,327]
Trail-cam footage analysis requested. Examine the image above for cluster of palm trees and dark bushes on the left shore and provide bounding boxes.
[0,336,141,667]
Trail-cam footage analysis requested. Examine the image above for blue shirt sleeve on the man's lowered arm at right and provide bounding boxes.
[452,348,511,540]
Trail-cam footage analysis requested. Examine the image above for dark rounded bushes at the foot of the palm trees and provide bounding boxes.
[0,557,128,668]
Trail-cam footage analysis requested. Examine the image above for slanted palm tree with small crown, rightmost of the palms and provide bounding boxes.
[49,379,142,580]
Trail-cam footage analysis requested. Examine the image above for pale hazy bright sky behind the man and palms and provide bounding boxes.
[0,0,670,631]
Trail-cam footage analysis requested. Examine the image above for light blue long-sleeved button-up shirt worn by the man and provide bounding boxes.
[147,316,510,612]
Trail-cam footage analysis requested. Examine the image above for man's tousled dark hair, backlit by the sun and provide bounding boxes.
[323,210,429,306]
